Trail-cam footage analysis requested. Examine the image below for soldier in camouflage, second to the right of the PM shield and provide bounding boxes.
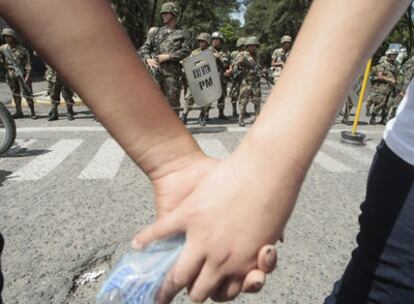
[237,37,262,127]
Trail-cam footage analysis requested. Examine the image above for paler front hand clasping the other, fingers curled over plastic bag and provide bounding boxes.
[133,151,299,303]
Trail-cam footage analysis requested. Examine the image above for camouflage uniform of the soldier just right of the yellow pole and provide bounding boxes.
[367,61,398,124]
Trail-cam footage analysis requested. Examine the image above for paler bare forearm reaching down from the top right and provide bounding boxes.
[237,0,410,209]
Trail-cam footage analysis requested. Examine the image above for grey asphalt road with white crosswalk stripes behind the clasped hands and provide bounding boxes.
[0,84,383,304]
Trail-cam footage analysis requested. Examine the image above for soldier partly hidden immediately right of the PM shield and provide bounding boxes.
[211,32,232,120]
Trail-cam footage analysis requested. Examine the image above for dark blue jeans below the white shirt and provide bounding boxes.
[325,142,414,304]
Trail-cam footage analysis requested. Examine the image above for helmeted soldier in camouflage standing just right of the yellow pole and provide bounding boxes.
[367,50,398,125]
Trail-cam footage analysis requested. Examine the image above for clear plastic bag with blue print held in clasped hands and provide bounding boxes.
[97,235,185,304]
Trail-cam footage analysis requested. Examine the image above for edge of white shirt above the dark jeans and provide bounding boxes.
[384,81,414,166]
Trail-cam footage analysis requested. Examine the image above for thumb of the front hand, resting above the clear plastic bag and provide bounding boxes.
[131,212,185,250]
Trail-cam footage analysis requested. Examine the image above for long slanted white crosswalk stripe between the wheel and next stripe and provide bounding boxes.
[10,139,83,181]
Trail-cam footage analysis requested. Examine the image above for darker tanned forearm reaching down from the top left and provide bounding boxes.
[0,0,199,174]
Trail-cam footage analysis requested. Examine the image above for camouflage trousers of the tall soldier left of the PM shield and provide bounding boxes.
[156,70,182,113]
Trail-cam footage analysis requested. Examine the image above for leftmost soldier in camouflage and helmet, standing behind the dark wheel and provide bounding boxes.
[0,28,37,119]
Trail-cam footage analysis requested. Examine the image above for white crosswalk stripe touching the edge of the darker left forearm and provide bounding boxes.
[79,138,125,179]
